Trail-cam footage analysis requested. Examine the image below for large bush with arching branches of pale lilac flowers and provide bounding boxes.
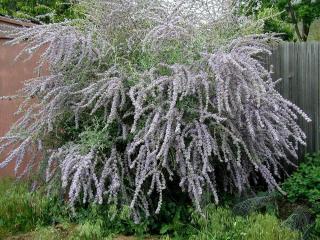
[0,0,309,220]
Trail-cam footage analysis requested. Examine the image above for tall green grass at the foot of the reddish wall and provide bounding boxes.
[0,178,67,239]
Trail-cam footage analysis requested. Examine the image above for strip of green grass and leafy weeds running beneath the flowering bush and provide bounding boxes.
[0,176,300,240]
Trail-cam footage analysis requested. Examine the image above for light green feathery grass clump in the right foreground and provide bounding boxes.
[191,206,300,240]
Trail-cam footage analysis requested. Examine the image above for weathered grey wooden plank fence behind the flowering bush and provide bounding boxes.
[266,42,320,152]
